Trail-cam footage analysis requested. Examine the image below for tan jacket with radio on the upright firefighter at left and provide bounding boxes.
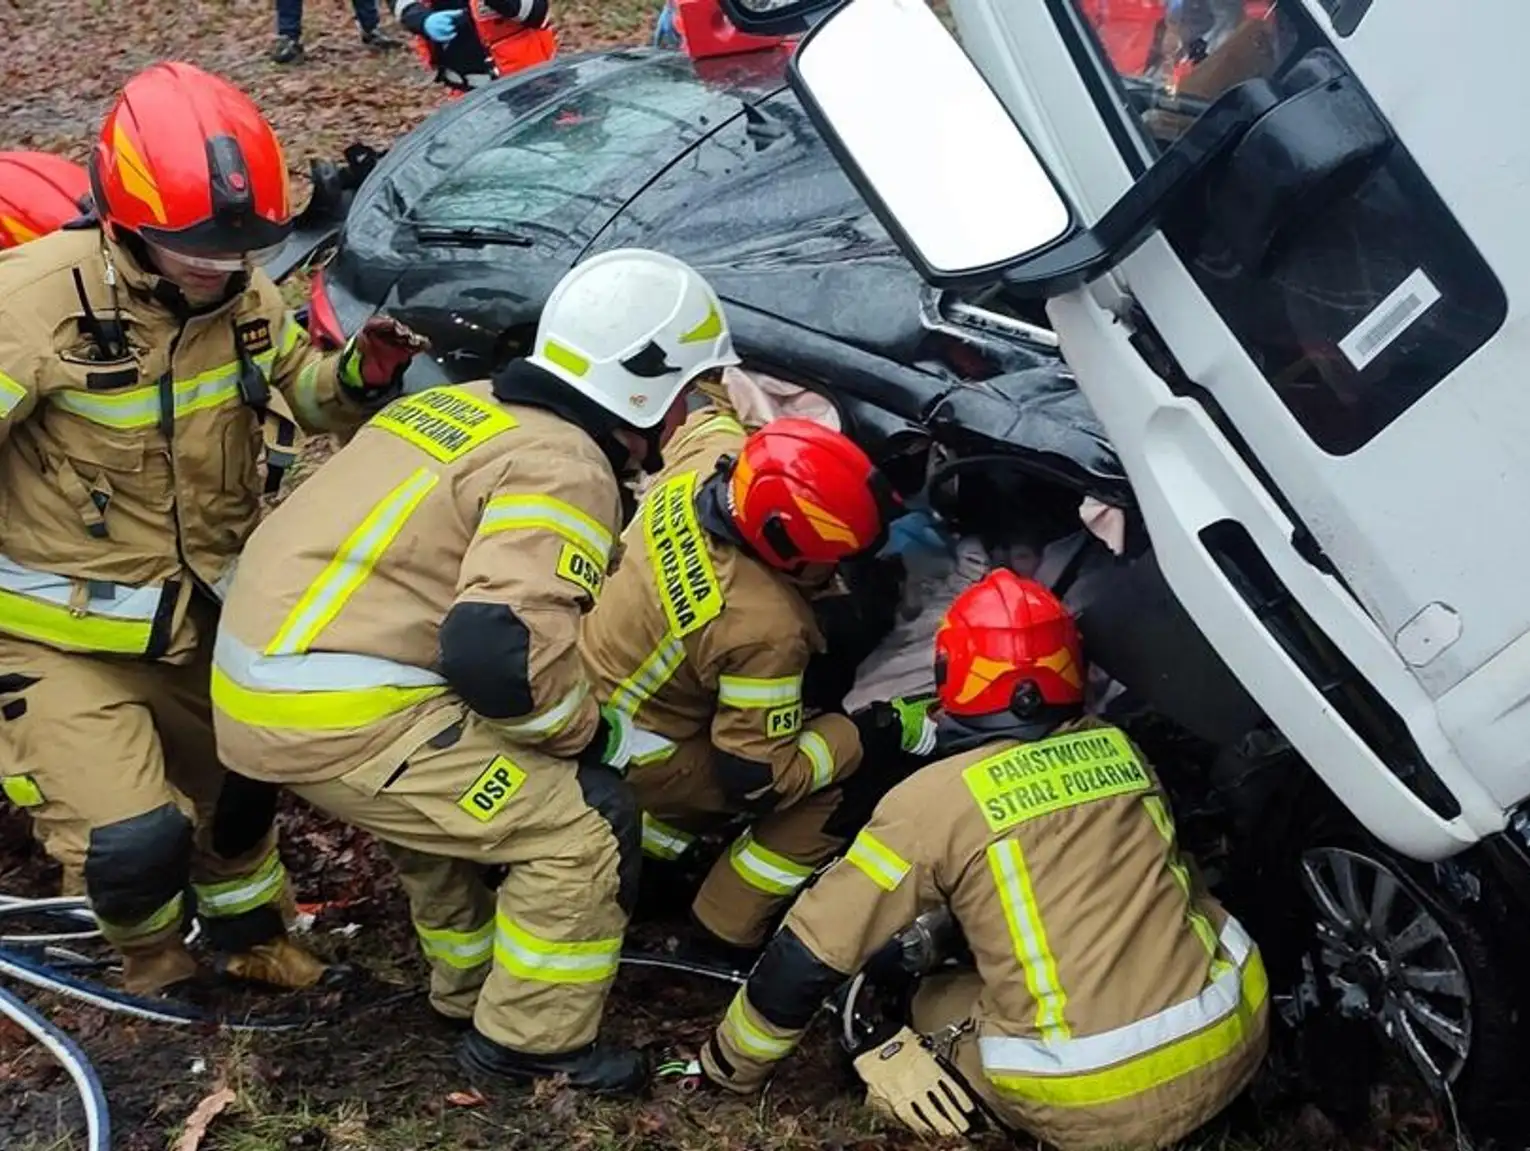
[0,230,364,661]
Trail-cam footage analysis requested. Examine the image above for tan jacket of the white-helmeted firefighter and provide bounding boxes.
[213,381,621,782]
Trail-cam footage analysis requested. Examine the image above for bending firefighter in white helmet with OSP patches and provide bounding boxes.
[213,249,731,1091]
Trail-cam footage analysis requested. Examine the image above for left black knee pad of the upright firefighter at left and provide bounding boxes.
[86,804,191,924]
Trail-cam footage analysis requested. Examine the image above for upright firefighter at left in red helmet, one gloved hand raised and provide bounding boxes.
[0,63,412,992]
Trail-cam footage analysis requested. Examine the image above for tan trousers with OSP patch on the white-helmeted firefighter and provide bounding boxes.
[289,704,641,1055]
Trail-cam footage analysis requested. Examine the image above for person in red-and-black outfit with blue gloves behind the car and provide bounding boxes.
[393,0,558,95]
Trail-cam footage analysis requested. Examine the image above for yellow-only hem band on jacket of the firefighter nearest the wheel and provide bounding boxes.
[985,952,1270,1107]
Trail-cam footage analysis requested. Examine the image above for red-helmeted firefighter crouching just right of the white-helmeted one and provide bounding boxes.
[580,419,897,963]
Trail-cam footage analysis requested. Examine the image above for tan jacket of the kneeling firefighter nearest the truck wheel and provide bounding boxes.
[718,719,1268,1148]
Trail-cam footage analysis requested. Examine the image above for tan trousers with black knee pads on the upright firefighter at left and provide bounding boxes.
[0,624,291,958]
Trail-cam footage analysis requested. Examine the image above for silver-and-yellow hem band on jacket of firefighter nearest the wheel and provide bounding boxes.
[978,920,1270,1107]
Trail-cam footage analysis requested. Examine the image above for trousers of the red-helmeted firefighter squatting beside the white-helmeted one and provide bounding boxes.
[627,739,846,949]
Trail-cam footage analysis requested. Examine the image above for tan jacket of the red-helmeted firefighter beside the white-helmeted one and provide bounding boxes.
[580,407,860,811]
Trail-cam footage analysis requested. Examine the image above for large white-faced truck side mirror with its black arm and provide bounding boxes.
[789,0,1394,298]
